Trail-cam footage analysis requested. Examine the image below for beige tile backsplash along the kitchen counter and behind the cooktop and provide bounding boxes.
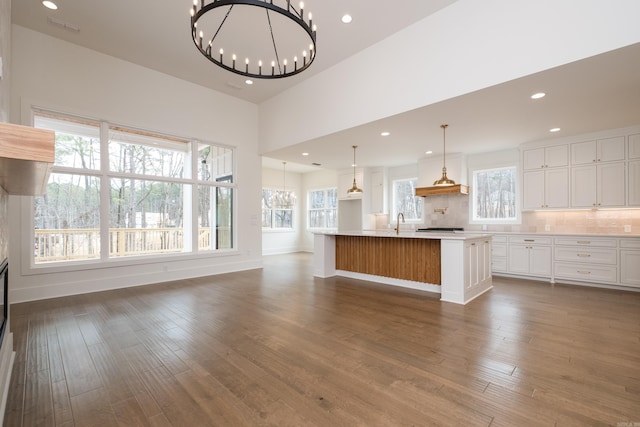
[424,195,640,235]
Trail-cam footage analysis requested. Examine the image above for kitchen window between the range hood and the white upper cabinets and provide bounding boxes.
[471,166,519,224]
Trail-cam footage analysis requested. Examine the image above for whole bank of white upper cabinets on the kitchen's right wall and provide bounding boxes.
[522,127,640,210]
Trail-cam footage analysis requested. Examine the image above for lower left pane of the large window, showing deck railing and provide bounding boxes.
[34,173,100,263]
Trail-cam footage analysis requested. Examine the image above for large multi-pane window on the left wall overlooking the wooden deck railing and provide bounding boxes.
[34,111,235,263]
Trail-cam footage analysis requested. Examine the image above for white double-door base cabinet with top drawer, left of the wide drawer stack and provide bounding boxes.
[507,236,551,277]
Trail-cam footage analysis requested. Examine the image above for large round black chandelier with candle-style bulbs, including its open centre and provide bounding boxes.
[191,0,316,79]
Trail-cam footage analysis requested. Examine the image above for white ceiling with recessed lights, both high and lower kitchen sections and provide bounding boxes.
[12,0,640,172]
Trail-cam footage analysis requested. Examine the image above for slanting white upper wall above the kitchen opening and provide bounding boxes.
[260,0,640,153]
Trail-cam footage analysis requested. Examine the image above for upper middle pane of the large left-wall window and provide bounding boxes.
[109,127,191,178]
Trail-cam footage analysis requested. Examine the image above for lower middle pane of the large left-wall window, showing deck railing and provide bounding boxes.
[109,178,185,257]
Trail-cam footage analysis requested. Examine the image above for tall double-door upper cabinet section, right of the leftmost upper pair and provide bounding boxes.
[571,162,626,208]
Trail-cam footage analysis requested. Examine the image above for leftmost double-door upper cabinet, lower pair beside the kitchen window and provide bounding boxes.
[522,168,569,210]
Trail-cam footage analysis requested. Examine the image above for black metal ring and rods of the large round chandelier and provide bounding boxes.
[191,0,317,79]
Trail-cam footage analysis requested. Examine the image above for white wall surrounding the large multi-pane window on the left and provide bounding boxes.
[9,25,262,302]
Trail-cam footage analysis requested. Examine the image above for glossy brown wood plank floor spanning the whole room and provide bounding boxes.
[4,254,640,427]
